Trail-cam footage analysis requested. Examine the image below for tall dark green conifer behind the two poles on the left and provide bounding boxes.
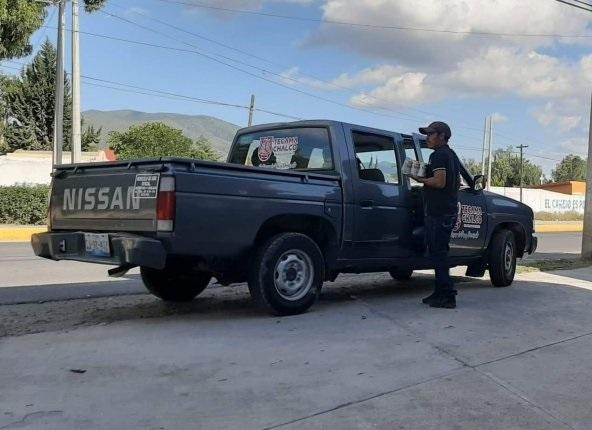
[0,40,101,151]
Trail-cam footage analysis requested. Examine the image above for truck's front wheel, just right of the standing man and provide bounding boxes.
[489,230,516,287]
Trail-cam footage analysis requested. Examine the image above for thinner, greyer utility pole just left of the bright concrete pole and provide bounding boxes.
[53,0,66,166]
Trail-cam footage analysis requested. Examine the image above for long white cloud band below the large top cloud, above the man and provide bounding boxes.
[285,48,592,109]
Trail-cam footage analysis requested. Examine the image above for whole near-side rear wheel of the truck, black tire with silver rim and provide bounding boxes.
[249,233,325,315]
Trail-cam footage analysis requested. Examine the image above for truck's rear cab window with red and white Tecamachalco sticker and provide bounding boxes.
[230,127,333,170]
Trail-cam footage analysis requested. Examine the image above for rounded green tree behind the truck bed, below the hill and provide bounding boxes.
[108,122,218,160]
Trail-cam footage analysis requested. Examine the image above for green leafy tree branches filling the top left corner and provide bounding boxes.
[0,0,106,60]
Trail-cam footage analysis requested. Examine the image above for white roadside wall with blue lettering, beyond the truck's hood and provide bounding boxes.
[491,187,585,214]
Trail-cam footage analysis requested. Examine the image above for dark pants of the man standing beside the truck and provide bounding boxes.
[425,215,456,296]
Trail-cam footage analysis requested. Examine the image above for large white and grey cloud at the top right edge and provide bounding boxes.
[308,0,592,70]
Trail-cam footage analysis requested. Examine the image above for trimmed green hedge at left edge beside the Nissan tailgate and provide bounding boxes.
[0,185,49,225]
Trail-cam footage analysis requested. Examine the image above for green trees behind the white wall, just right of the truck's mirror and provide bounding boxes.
[491,147,543,187]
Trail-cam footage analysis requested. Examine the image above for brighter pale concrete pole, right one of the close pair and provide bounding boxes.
[71,0,82,163]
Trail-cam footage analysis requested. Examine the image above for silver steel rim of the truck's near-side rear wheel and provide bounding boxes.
[273,249,314,302]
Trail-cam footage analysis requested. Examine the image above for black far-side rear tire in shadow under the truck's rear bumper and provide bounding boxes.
[140,264,212,302]
